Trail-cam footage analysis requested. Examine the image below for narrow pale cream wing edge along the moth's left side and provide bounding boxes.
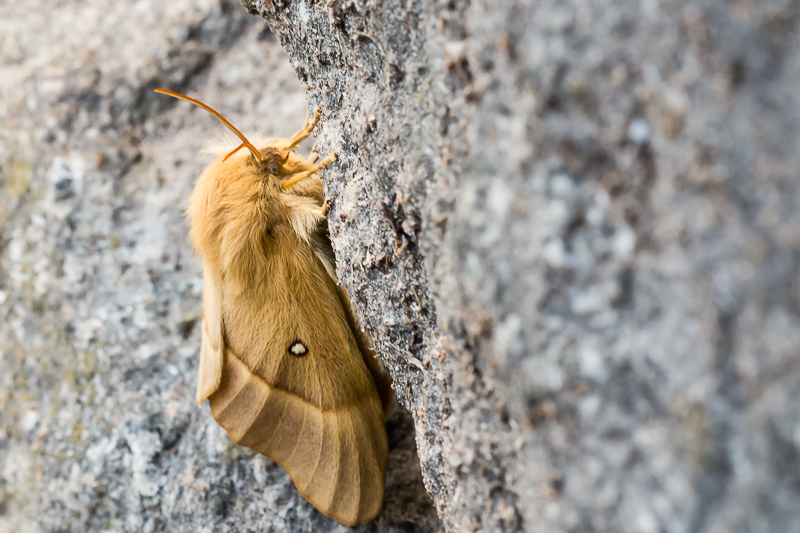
[195,264,224,404]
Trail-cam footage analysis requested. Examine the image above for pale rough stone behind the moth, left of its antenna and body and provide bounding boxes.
[0,0,441,533]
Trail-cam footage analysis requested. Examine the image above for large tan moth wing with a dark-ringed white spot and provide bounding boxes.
[210,231,388,525]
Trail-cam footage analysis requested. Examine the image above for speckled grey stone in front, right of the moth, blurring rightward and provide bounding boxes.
[244,0,800,533]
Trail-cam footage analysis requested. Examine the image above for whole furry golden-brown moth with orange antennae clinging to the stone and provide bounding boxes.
[156,89,392,525]
